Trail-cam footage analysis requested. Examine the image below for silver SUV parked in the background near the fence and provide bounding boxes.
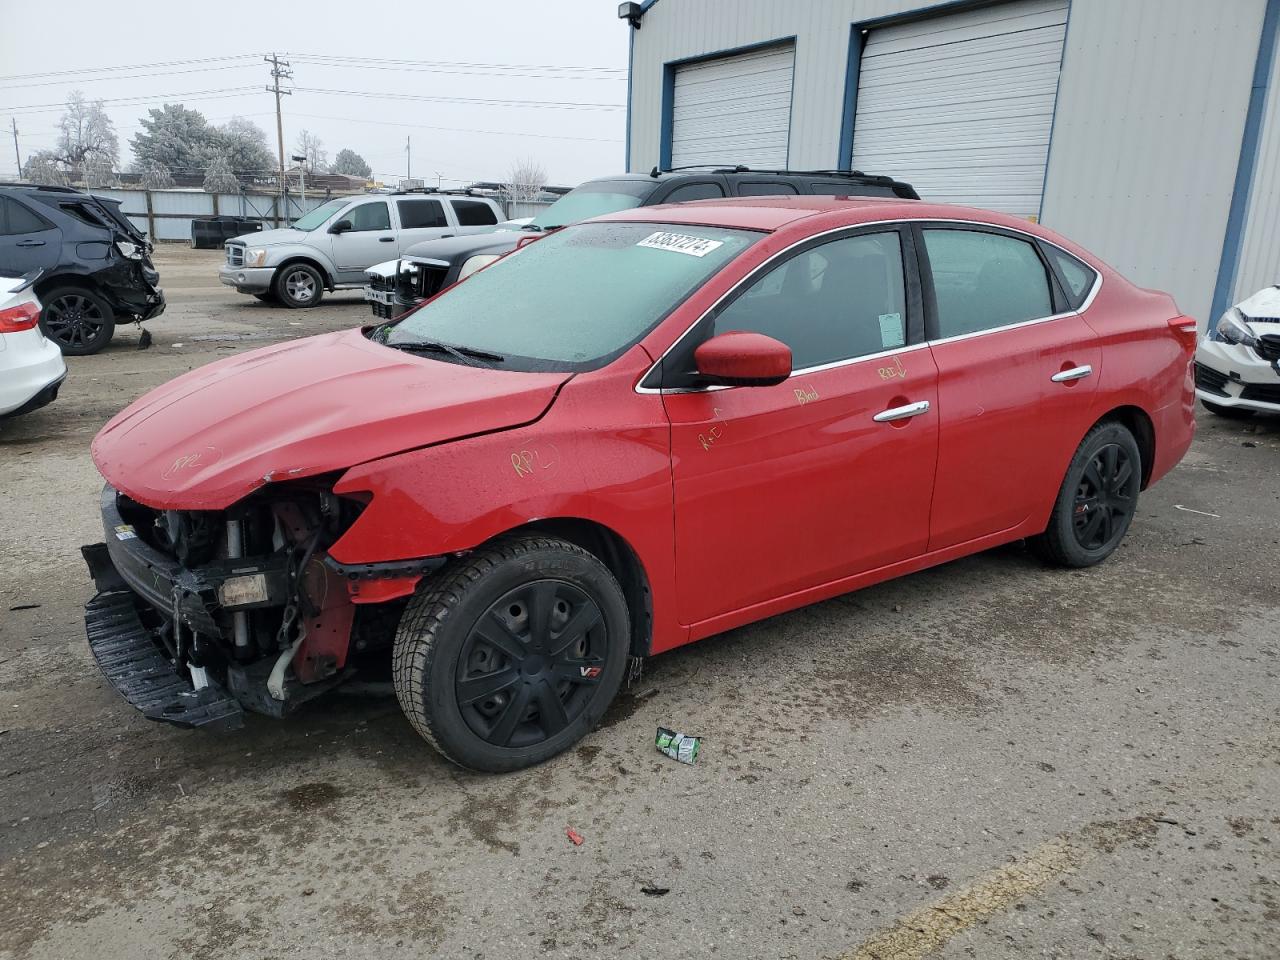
[218,189,506,307]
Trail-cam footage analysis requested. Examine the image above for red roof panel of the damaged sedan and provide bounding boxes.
[595,195,1043,236]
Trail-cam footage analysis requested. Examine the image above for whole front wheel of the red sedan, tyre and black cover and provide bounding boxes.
[393,536,631,773]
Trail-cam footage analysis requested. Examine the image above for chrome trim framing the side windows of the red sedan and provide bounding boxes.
[635,216,1102,393]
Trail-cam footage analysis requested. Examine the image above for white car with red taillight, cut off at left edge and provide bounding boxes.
[0,270,67,420]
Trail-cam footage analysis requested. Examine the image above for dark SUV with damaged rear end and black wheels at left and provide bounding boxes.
[0,183,164,356]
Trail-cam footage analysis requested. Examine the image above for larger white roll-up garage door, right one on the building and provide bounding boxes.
[852,0,1068,216]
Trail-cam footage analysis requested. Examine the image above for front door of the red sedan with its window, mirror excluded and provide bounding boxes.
[663,225,938,623]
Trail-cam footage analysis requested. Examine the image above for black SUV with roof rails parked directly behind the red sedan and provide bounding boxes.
[365,166,920,320]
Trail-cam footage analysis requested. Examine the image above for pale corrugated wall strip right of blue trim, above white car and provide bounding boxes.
[1215,22,1280,302]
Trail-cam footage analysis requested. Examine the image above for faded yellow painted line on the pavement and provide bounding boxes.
[835,817,1156,960]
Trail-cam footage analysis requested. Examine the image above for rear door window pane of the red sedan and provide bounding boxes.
[924,229,1053,339]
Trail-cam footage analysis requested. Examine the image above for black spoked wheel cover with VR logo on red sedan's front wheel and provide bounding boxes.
[454,580,608,746]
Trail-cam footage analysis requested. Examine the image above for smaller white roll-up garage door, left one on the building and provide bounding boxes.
[671,44,795,169]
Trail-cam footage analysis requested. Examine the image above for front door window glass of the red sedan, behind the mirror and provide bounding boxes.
[712,230,906,370]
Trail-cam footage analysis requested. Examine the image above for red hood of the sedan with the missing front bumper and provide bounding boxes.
[92,330,572,509]
